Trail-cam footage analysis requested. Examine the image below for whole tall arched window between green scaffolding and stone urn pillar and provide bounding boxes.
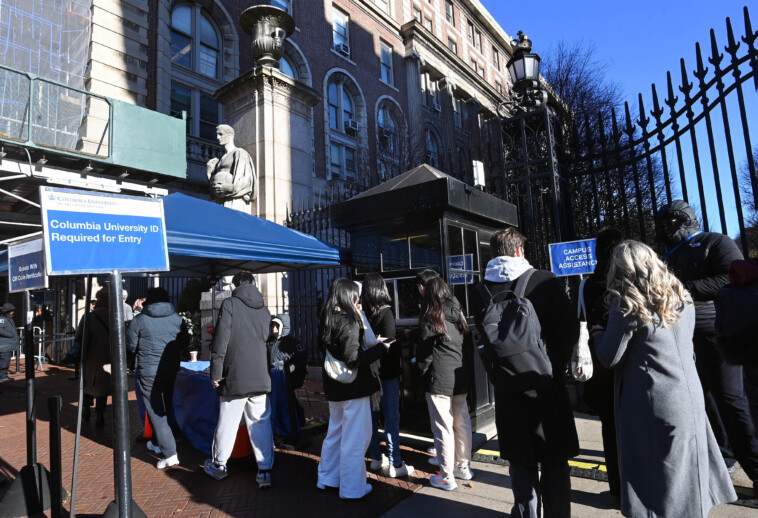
[171,3,222,141]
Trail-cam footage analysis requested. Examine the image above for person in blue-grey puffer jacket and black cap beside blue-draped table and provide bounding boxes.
[126,288,189,469]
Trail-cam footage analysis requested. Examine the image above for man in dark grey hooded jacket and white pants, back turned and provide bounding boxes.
[203,272,274,489]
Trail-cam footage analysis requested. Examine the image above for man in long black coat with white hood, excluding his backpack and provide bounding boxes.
[472,228,579,518]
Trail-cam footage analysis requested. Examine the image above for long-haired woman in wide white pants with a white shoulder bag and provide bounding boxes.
[316,278,386,499]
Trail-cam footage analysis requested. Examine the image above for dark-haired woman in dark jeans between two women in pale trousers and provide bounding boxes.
[361,272,413,478]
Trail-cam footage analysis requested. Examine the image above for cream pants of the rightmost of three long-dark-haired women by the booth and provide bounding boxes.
[426,398,471,478]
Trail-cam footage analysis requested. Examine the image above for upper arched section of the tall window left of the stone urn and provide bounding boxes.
[171,5,221,79]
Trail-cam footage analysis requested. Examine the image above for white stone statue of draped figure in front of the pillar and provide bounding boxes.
[207,124,256,214]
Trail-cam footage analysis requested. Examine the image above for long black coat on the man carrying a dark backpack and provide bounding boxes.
[472,270,579,462]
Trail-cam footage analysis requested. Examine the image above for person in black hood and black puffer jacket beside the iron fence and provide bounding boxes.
[656,200,758,487]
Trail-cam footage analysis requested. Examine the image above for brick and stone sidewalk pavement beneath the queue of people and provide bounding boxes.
[0,366,758,518]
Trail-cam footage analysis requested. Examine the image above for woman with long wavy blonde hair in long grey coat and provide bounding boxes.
[591,241,737,518]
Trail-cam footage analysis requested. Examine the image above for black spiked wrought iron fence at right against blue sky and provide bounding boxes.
[560,7,758,256]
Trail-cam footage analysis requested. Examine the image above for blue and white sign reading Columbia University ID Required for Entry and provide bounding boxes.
[40,187,169,275]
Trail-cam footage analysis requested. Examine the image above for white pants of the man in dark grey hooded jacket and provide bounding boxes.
[213,394,274,470]
